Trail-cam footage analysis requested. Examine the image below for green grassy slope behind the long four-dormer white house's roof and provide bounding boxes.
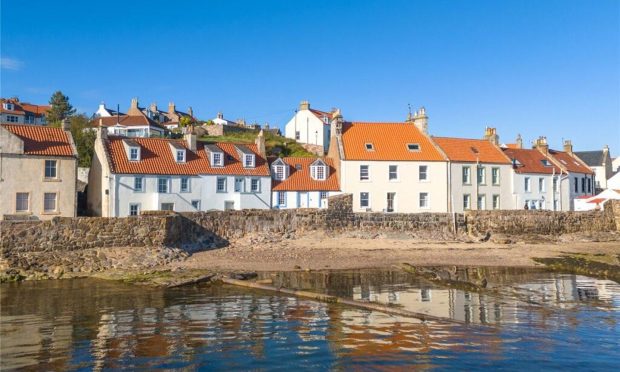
[199,132,316,157]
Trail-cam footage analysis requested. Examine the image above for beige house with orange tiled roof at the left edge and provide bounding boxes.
[0,124,77,220]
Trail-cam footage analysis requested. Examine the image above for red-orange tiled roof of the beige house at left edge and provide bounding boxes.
[2,124,76,156]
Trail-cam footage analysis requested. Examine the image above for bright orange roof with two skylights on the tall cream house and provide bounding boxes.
[342,122,446,161]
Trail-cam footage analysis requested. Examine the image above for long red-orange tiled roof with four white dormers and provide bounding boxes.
[106,136,270,176]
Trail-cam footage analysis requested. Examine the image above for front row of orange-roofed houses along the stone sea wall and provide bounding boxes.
[0,101,612,219]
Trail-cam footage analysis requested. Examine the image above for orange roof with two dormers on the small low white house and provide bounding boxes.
[272,157,340,191]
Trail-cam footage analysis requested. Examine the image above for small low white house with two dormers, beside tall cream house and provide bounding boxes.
[271,157,340,209]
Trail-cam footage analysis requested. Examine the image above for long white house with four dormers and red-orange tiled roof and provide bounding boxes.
[88,128,271,217]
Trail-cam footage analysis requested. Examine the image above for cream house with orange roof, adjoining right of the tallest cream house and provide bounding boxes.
[433,128,513,213]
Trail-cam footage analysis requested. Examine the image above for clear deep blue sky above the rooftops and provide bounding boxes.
[0,0,620,156]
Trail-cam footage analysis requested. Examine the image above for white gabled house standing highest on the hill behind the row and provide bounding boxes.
[284,101,338,155]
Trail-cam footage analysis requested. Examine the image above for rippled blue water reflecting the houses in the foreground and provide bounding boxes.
[0,269,620,370]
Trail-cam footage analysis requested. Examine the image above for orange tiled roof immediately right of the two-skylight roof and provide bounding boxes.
[433,137,510,164]
